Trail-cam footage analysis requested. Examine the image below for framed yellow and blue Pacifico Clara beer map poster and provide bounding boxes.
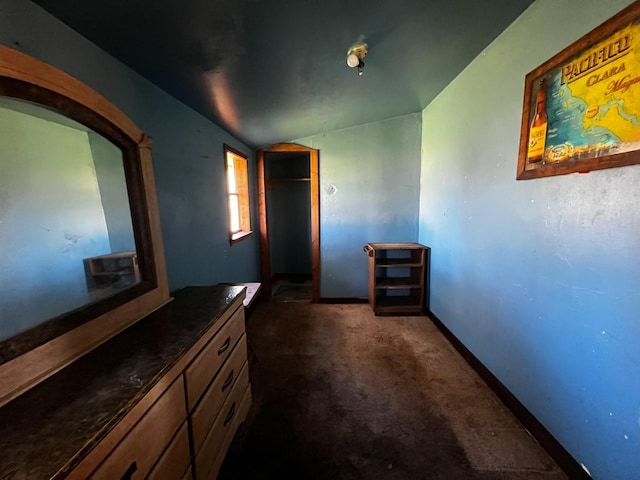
[517,1,640,180]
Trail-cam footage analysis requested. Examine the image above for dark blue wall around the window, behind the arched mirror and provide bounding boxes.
[0,0,259,290]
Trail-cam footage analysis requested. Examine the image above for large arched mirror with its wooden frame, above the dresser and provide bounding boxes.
[0,47,169,405]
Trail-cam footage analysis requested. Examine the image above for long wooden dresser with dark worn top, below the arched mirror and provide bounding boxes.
[0,286,251,480]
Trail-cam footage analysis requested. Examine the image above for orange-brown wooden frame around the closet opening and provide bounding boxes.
[256,143,320,303]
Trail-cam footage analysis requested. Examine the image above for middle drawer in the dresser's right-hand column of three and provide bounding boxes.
[191,335,248,455]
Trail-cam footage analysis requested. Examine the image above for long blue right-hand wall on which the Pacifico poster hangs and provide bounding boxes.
[419,0,640,480]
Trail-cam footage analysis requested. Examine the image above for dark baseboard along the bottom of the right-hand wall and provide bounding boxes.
[428,311,591,480]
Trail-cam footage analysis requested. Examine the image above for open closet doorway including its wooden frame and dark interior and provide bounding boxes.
[256,143,320,303]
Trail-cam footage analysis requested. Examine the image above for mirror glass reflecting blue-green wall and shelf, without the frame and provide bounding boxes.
[0,97,140,341]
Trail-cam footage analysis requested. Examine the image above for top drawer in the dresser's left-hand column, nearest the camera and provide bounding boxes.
[91,376,187,480]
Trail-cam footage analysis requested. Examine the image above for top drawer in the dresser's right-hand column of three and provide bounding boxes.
[184,307,244,411]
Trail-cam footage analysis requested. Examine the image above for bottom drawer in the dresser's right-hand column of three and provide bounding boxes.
[195,370,251,480]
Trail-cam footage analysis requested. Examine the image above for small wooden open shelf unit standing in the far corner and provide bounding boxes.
[363,243,431,315]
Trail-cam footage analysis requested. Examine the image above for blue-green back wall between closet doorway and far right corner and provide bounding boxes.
[295,113,421,298]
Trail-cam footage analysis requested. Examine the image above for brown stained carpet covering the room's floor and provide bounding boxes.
[219,303,566,480]
